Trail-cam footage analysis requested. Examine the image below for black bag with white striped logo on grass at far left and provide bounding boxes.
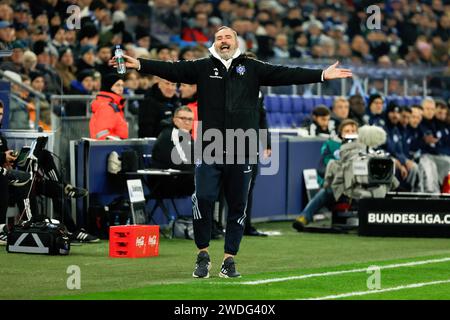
[6,219,70,255]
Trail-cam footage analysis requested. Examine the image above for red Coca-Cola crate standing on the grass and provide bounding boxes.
[109,225,159,258]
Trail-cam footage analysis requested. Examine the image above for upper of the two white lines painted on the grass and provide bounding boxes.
[237,258,450,285]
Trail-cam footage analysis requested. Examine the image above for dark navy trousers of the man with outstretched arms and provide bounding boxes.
[192,164,253,255]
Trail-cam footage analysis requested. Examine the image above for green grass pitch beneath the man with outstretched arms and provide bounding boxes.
[0,222,450,300]
